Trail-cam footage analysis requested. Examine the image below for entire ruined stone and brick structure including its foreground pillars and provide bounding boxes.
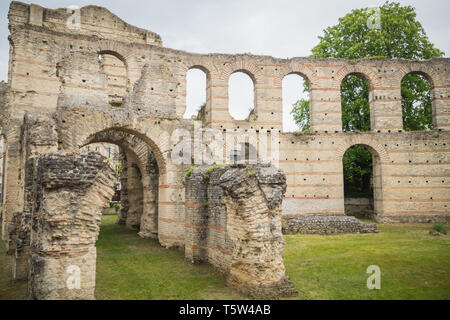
[0,1,450,299]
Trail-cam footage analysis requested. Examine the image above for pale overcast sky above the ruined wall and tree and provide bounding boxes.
[0,0,450,130]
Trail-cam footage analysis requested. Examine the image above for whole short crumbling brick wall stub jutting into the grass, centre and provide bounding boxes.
[185,165,296,298]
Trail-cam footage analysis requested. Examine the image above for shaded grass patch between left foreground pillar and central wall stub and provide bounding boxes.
[95,216,242,300]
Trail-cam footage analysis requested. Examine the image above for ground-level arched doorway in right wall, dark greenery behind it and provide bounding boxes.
[343,145,374,218]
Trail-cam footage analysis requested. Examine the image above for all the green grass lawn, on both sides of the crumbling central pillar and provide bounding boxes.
[0,216,450,300]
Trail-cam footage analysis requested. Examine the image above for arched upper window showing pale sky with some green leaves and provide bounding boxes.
[282,74,310,133]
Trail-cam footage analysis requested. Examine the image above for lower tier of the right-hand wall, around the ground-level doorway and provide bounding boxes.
[280,131,450,222]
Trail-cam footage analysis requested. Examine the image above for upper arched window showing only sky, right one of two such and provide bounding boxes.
[228,71,255,120]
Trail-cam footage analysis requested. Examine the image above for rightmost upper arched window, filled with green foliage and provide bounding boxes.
[401,73,433,131]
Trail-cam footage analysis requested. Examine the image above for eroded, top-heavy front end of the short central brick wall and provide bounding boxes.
[220,166,297,298]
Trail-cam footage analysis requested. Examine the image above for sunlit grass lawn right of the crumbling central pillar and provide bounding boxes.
[283,225,450,300]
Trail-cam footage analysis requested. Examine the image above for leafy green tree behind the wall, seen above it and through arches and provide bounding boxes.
[292,2,444,198]
